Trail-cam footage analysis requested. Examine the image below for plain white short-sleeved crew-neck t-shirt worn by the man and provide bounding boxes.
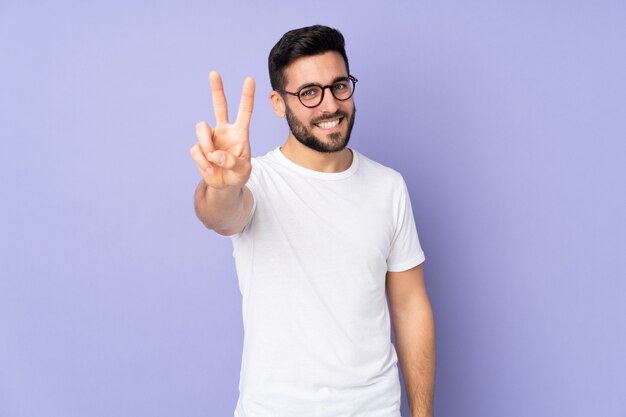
[232,148,424,417]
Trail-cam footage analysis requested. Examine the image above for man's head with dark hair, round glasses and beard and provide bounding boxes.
[268,25,356,152]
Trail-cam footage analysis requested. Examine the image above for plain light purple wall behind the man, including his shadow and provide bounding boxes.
[0,0,626,417]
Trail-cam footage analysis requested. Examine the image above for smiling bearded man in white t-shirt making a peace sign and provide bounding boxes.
[191,26,435,417]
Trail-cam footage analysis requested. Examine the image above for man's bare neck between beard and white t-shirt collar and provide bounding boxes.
[280,134,352,172]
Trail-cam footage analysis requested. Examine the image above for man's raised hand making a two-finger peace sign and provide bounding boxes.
[190,71,254,189]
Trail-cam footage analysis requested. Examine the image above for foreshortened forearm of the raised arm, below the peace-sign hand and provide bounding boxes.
[194,181,245,234]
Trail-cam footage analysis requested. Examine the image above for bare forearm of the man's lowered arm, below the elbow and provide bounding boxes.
[394,304,435,417]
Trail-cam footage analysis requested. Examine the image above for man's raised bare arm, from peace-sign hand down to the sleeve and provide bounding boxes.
[190,71,254,235]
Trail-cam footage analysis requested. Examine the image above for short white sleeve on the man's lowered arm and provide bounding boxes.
[387,179,426,272]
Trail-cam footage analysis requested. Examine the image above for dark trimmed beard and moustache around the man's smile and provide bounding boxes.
[285,106,356,153]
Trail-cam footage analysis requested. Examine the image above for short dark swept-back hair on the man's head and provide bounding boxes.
[267,25,350,89]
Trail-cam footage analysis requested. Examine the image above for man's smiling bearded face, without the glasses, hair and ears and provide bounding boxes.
[284,52,356,153]
